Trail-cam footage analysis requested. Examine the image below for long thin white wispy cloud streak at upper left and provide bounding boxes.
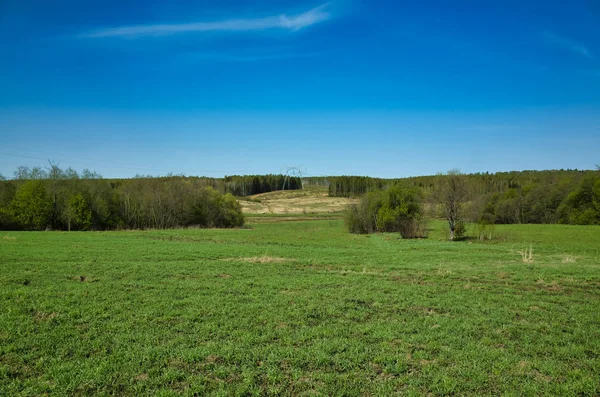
[80,3,333,38]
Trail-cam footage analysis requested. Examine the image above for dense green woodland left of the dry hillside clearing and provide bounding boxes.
[0,165,301,230]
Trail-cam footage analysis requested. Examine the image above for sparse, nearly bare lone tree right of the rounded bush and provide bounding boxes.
[437,170,468,240]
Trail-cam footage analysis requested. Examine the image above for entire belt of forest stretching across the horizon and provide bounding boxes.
[0,164,600,230]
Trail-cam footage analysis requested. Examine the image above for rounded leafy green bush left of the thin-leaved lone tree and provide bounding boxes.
[345,185,427,238]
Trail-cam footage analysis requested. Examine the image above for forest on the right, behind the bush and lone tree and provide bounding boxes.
[328,170,600,225]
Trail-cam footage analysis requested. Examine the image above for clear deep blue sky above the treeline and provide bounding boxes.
[0,0,600,177]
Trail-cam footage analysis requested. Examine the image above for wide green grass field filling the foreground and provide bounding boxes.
[0,218,600,396]
